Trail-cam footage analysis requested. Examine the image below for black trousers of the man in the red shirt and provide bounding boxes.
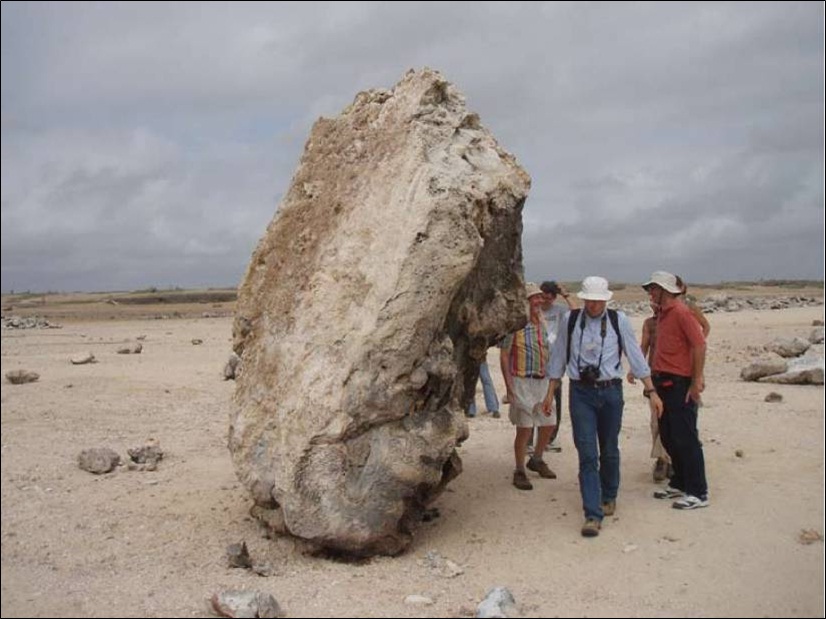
[654,374,708,498]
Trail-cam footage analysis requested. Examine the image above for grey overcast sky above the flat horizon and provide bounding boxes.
[2,2,824,292]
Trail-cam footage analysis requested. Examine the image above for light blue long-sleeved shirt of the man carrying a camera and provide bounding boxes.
[548,308,651,380]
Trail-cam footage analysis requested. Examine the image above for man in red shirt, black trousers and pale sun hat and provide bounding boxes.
[642,271,708,509]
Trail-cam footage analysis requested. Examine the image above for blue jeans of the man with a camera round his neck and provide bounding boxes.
[568,381,625,521]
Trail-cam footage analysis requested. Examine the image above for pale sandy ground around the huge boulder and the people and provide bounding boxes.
[2,307,824,617]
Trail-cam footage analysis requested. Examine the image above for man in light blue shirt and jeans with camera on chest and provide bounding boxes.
[549,276,662,537]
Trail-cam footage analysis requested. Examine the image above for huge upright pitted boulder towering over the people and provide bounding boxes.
[229,69,530,555]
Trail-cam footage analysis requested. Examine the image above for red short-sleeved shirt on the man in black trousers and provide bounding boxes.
[651,303,706,378]
